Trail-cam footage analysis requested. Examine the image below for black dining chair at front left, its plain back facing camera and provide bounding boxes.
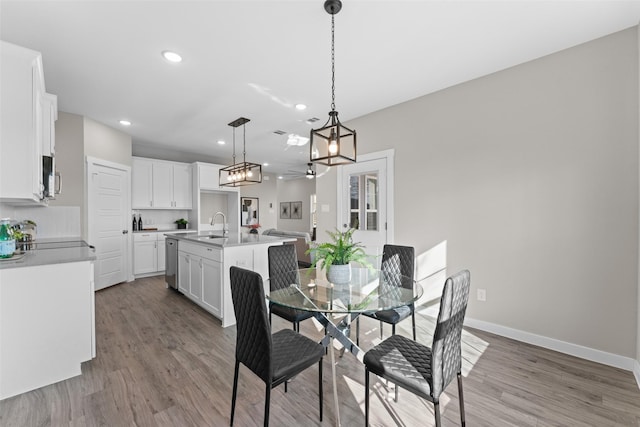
[229,267,324,426]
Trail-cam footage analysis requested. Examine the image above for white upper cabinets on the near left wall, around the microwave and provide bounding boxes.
[0,41,57,204]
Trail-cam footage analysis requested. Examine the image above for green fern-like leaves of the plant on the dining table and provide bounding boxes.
[306,228,373,271]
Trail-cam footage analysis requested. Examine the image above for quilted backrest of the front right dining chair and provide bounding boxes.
[431,270,471,398]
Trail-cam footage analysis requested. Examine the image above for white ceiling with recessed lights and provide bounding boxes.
[0,0,640,176]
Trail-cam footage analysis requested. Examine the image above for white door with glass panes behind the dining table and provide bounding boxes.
[337,151,393,265]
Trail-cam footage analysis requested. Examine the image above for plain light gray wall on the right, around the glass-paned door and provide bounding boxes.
[317,27,640,358]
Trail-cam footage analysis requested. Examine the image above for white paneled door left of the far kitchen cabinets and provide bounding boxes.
[87,159,131,290]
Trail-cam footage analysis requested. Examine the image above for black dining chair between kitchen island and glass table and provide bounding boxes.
[268,244,313,332]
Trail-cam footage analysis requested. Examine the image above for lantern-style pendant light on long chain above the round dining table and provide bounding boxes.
[309,0,356,166]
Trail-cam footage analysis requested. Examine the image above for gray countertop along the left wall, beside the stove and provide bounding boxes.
[0,237,96,270]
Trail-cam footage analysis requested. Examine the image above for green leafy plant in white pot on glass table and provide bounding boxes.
[306,228,373,283]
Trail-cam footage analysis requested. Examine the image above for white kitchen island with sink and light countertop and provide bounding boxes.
[171,232,295,327]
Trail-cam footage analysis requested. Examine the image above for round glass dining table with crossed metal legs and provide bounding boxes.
[267,267,422,425]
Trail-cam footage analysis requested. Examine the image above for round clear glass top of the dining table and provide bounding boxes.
[268,267,422,313]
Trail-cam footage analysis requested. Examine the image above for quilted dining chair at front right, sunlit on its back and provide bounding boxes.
[364,270,470,427]
